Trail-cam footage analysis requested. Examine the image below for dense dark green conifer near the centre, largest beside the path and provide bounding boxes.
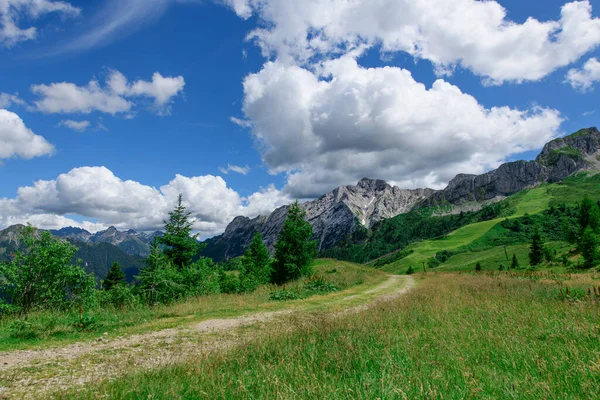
[273,202,317,283]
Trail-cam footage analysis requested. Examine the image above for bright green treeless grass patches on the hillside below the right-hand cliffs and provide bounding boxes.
[383,173,600,273]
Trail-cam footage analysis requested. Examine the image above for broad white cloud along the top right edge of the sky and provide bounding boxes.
[226,0,600,84]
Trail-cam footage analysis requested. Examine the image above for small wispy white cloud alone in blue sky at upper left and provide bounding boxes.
[31,71,185,115]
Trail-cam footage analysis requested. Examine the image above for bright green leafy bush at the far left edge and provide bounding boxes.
[0,226,95,312]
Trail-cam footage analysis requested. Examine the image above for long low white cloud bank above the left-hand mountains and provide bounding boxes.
[0,167,290,236]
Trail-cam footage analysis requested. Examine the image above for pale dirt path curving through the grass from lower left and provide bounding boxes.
[0,275,415,399]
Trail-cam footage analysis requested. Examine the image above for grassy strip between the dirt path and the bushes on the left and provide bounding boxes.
[0,260,388,351]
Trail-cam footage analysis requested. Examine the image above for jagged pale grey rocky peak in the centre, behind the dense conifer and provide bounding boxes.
[204,178,434,260]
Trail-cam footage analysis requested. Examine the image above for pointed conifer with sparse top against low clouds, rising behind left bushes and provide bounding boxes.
[158,195,200,268]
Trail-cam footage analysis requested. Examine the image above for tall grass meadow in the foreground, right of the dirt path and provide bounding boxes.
[57,273,600,399]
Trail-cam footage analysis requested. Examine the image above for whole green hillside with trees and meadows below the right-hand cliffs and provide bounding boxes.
[323,172,600,273]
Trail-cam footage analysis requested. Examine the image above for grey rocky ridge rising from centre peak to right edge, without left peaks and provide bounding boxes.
[203,128,600,260]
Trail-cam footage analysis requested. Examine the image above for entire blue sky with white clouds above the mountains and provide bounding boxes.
[0,0,600,237]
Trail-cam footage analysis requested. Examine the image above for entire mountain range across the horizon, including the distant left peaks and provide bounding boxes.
[0,128,600,272]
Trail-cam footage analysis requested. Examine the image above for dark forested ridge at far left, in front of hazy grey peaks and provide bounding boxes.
[0,225,144,281]
